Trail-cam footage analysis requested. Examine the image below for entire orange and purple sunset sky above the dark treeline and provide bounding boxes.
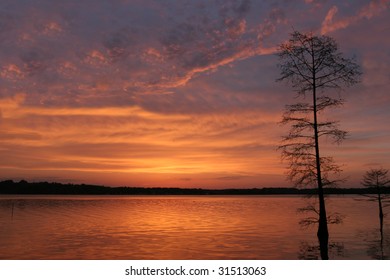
[0,0,390,188]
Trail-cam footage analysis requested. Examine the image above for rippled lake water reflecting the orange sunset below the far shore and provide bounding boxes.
[0,196,390,259]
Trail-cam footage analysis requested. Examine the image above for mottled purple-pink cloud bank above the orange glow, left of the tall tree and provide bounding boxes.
[0,0,284,106]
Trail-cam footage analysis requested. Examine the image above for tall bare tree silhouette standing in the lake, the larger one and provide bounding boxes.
[277,31,361,259]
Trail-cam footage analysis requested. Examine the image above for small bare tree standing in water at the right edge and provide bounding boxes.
[362,168,390,242]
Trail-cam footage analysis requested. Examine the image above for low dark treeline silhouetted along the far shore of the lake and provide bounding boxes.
[0,180,390,195]
